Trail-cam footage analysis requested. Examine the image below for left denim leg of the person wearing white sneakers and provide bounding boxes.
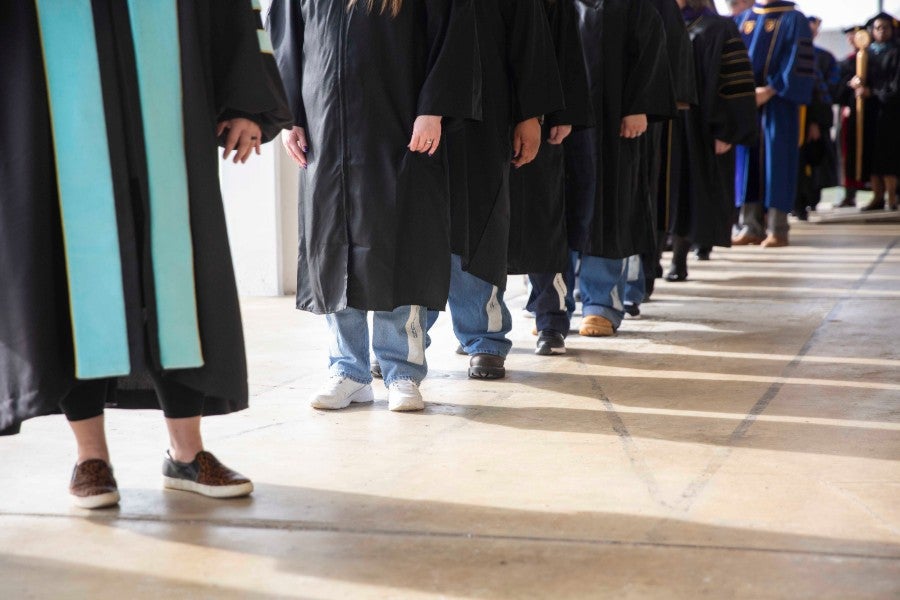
[325,308,372,383]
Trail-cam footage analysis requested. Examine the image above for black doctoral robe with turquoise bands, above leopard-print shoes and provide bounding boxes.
[0,0,290,433]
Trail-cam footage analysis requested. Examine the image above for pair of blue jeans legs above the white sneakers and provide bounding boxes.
[325,306,428,385]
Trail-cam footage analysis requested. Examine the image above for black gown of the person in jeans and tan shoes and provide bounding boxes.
[564,0,676,258]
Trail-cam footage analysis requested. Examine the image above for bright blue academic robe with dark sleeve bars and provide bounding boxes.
[735,1,816,212]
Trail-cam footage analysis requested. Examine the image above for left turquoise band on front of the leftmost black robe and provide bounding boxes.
[34,0,131,379]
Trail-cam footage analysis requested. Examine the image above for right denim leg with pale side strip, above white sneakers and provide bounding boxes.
[372,306,428,385]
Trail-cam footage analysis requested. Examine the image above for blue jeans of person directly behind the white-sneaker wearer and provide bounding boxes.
[428,254,512,358]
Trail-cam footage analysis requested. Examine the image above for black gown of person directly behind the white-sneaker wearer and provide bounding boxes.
[447,0,564,289]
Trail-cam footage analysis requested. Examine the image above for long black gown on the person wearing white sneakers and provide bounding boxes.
[266,0,481,313]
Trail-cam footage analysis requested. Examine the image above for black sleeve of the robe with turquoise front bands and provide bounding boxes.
[209,0,291,142]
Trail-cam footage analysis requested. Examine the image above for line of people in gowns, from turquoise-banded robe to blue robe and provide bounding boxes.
[0,0,896,508]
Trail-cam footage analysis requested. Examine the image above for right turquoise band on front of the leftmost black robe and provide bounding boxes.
[128,0,204,369]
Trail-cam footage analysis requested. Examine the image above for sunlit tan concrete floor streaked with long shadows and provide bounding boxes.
[0,223,900,599]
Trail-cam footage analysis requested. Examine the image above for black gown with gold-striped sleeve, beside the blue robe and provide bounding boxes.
[671,13,759,247]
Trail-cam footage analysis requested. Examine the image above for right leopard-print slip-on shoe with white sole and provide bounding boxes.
[163,450,253,498]
